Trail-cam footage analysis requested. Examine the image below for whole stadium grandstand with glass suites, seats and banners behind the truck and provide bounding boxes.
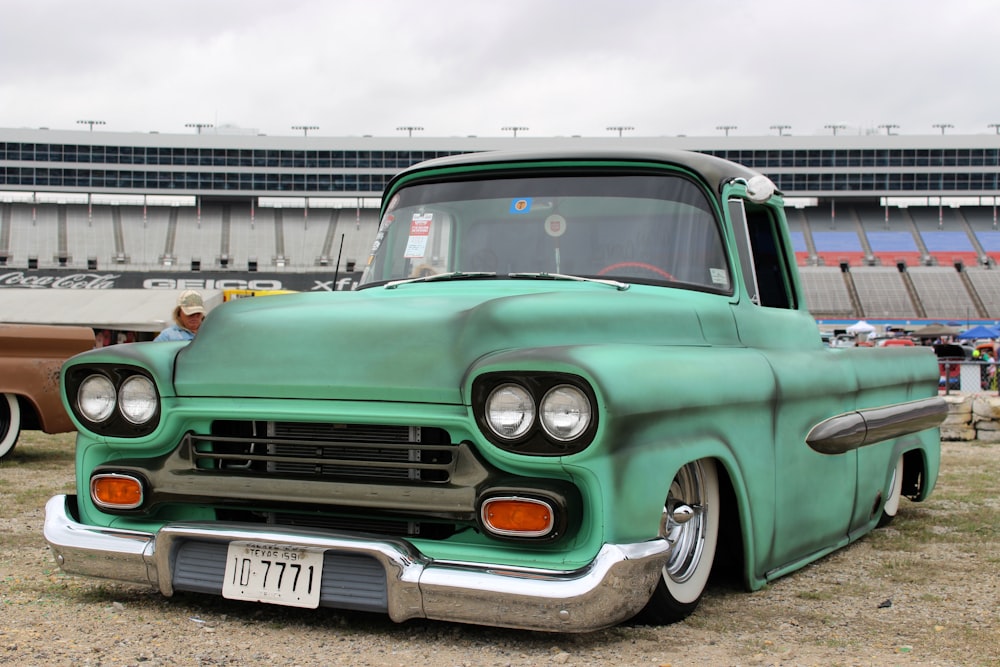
[0,127,1000,332]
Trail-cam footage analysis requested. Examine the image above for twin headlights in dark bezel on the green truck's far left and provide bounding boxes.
[63,364,161,438]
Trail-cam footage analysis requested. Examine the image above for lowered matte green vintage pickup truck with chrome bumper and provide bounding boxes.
[45,151,947,632]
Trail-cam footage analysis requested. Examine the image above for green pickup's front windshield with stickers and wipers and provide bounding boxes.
[361,173,731,292]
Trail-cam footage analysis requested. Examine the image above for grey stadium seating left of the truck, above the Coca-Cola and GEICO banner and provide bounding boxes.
[0,203,378,271]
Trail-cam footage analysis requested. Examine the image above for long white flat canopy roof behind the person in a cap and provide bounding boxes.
[0,288,222,332]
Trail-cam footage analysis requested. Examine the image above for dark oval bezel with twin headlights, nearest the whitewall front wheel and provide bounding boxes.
[472,371,598,456]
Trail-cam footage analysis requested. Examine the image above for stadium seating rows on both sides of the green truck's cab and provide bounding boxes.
[0,202,1000,321]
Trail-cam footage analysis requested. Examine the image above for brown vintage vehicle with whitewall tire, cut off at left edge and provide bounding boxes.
[0,324,94,459]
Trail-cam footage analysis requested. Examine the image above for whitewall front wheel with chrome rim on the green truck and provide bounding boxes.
[641,460,720,625]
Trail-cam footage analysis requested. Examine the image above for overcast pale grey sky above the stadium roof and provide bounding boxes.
[0,0,1000,137]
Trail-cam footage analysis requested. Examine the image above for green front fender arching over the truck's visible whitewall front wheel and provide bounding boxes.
[470,345,777,587]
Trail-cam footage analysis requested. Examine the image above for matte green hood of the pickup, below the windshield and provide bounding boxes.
[174,281,736,405]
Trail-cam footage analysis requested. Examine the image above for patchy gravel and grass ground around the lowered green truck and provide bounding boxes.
[0,436,1000,667]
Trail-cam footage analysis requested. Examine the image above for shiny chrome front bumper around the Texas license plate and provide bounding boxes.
[44,495,670,632]
